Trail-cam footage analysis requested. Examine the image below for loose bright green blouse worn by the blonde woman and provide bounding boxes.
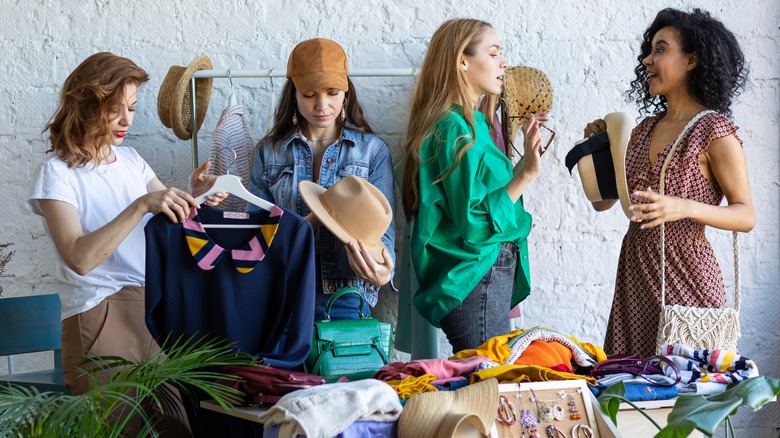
[411,105,531,327]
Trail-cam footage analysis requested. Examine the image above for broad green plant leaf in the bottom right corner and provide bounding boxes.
[656,376,780,438]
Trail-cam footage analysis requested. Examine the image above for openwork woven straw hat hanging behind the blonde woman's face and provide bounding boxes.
[501,65,553,141]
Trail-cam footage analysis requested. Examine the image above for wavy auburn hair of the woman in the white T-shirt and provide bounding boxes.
[43,52,149,167]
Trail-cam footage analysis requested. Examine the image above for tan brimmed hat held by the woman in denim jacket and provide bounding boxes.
[298,176,393,263]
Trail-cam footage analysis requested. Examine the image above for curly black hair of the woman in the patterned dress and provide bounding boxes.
[626,8,748,117]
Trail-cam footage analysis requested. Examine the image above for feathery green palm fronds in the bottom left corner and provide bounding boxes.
[0,334,252,437]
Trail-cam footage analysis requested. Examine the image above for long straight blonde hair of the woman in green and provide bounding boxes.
[402,18,495,219]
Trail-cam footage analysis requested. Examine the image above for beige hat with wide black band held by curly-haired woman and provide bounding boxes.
[566,112,634,219]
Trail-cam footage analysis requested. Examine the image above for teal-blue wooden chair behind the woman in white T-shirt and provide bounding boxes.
[0,294,70,394]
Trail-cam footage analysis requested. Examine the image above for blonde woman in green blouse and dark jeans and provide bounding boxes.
[403,19,546,351]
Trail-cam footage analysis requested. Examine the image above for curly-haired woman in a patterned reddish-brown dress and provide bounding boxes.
[585,9,756,356]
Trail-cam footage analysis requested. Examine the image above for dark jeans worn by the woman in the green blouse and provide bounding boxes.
[441,242,518,352]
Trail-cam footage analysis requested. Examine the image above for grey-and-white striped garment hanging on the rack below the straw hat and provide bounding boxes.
[209,105,254,211]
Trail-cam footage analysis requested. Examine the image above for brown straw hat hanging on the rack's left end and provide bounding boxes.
[157,56,214,140]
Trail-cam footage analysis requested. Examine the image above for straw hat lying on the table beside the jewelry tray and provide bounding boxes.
[398,379,498,438]
